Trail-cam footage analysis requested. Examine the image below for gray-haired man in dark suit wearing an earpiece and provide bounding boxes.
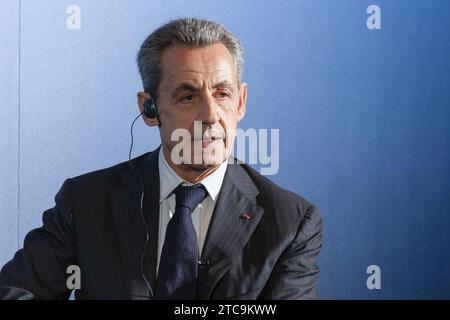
[0,18,322,299]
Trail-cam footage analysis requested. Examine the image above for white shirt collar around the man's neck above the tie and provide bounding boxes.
[158,147,228,201]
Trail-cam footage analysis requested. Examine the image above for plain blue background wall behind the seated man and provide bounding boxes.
[0,0,450,299]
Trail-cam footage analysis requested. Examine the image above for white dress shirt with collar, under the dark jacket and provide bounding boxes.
[156,146,228,272]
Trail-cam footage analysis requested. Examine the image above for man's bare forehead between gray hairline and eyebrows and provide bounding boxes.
[161,43,236,86]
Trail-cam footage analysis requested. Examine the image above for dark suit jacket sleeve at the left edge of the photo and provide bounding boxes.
[0,180,75,300]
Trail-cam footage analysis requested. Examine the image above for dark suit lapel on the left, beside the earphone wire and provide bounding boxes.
[110,148,159,296]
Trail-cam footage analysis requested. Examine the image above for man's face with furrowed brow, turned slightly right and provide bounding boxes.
[149,43,247,171]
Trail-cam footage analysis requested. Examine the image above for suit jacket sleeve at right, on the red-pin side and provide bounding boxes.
[259,205,323,300]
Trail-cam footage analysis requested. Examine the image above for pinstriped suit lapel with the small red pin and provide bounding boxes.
[197,161,264,299]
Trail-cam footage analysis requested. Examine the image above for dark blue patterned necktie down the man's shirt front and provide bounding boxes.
[155,185,207,300]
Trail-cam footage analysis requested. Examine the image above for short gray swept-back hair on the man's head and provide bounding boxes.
[136,18,244,100]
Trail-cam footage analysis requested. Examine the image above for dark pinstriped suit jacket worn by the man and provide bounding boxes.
[0,148,322,299]
